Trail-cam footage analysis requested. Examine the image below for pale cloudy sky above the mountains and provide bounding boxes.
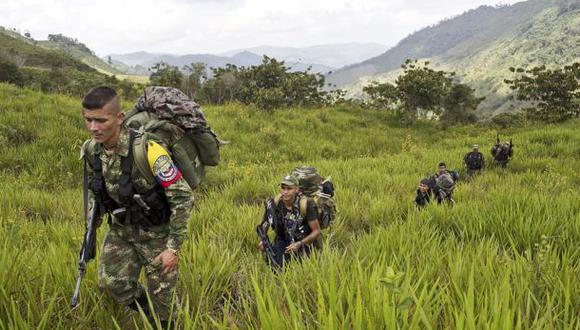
[0,0,520,55]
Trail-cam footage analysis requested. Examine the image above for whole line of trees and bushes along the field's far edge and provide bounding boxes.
[0,50,580,125]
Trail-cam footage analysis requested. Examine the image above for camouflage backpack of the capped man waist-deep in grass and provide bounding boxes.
[292,166,336,229]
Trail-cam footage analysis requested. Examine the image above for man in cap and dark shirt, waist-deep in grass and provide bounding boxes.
[258,175,320,268]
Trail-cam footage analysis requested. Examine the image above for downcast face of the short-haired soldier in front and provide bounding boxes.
[83,98,124,146]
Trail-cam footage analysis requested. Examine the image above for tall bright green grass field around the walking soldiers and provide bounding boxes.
[0,84,580,329]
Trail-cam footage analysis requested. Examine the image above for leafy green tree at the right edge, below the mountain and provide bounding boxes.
[504,62,580,122]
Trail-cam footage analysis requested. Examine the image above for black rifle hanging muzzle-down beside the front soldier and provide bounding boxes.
[72,203,104,308]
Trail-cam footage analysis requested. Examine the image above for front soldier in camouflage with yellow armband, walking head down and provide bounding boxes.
[82,87,194,327]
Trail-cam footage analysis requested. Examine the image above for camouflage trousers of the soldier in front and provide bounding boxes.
[99,223,178,320]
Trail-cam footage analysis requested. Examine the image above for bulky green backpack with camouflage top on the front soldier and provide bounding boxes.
[124,86,220,189]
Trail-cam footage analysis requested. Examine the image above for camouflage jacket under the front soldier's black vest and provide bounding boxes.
[81,128,194,250]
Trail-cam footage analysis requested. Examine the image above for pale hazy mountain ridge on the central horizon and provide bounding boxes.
[219,43,388,72]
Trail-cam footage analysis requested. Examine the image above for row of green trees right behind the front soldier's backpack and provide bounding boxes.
[150,56,343,110]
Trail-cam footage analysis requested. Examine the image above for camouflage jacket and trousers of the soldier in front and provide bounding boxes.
[83,128,193,320]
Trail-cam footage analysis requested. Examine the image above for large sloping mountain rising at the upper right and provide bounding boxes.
[327,0,580,113]
